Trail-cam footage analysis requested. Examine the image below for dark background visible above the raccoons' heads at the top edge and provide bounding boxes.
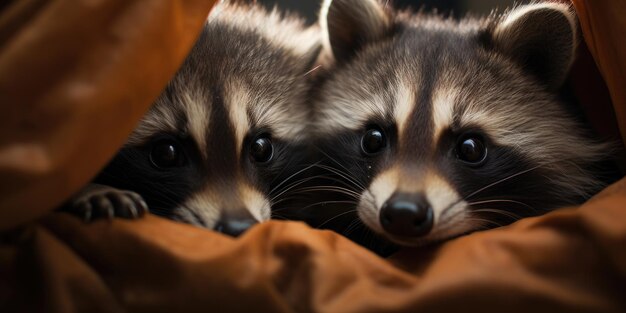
[259,0,529,22]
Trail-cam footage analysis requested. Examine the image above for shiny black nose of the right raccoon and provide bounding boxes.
[380,193,433,237]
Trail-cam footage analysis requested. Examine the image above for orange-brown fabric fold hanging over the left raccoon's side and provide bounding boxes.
[0,0,215,230]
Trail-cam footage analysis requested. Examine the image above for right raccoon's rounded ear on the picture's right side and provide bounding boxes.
[492,3,577,90]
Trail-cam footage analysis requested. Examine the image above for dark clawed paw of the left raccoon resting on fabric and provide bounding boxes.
[65,184,148,222]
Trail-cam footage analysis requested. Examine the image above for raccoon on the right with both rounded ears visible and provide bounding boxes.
[315,0,609,246]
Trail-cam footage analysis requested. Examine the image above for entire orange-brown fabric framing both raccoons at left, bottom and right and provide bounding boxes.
[0,0,626,312]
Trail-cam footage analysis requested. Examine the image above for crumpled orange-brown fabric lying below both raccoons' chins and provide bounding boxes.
[0,181,626,313]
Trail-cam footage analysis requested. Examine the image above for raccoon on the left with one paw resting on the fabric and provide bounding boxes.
[64,1,321,236]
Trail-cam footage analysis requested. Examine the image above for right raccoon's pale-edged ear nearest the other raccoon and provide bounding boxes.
[320,0,391,62]
